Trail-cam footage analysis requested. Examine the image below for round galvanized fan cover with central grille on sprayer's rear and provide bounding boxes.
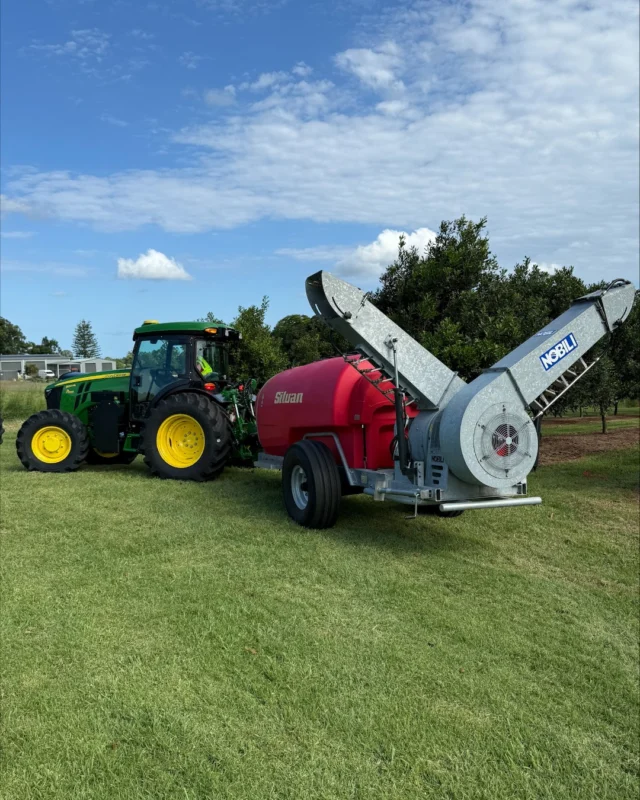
[473,402,537,481]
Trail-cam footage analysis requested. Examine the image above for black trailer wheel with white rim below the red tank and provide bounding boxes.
[282,440,342,528]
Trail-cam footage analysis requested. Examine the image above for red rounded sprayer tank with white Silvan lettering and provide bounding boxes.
[256,358,415,476]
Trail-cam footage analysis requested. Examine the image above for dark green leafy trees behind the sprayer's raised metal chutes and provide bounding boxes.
[218,216,640,432]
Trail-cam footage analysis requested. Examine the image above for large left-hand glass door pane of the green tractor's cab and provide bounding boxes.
[131,338,187,403]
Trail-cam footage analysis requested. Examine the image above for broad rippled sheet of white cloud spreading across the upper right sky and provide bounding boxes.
[6,0,639,280]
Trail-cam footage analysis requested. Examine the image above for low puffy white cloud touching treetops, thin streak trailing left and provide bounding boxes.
[276,228,436,283]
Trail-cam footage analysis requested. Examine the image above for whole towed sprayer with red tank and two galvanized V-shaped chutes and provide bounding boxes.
[256,272,635,528]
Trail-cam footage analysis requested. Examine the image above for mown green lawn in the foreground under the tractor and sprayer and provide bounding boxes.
[0,424,639,800]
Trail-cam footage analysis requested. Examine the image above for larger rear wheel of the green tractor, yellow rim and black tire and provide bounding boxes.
[141,392,233,481]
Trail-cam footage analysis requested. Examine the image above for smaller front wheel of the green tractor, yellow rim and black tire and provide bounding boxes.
[16,408,89,472]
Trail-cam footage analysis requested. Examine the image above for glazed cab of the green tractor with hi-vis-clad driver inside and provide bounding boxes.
[130,320,241,420]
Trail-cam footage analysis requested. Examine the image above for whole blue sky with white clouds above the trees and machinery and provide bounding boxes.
[0,0,639,356]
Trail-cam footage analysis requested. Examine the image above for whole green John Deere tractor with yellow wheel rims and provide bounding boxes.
[16,320,258,481]
